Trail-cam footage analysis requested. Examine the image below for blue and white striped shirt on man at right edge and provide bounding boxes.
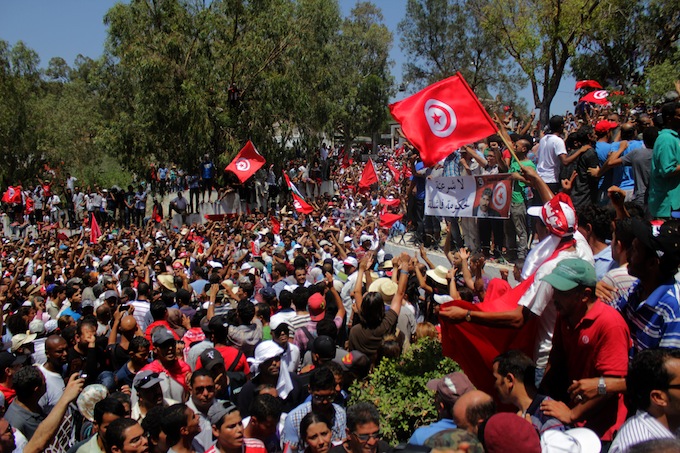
[614,278,680,357]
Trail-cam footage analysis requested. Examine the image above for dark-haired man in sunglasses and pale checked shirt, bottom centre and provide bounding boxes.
[281,367,346,450]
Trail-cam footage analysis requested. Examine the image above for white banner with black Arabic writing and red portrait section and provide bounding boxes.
[425,174,512,219]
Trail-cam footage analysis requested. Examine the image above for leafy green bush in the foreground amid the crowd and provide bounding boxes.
[350,338,460,445]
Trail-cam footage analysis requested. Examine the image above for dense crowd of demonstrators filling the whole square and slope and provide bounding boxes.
[0,89,680,453]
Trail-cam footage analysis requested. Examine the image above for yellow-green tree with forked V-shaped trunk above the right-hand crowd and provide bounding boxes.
[473,0,612,124]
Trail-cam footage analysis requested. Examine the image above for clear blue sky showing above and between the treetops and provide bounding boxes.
[0,0,576,114]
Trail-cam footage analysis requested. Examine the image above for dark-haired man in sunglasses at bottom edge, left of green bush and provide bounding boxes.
[328,402,390,453]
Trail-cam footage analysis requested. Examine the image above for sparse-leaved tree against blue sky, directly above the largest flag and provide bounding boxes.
[399,0,522,97]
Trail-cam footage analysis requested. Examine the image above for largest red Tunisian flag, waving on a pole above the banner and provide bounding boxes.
[390,73,498,167]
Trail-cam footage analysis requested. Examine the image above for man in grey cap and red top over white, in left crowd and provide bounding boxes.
[141,328,191,401]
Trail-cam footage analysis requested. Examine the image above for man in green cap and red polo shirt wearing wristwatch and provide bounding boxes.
[541,258,631,443]
